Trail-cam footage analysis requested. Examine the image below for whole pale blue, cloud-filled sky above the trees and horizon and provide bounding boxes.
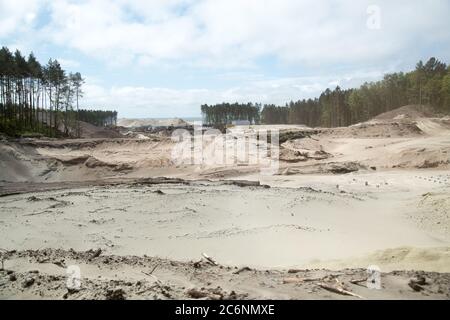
[0,0,450,118]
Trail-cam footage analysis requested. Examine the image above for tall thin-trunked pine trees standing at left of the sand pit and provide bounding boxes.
[0,47,117,136]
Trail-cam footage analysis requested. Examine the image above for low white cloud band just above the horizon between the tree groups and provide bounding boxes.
[82,72,381,118]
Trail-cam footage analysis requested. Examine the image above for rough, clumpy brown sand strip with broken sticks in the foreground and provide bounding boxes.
[0,249,450,300]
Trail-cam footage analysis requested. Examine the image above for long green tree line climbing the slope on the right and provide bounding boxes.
[261,58,450,127]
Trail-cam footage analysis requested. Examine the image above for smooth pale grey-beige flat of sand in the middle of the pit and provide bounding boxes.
[0,172,450,272]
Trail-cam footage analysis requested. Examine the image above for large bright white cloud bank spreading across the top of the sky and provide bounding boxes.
[32,0,450,67]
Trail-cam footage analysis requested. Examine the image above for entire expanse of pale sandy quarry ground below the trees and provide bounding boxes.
[0,111,450,299]
